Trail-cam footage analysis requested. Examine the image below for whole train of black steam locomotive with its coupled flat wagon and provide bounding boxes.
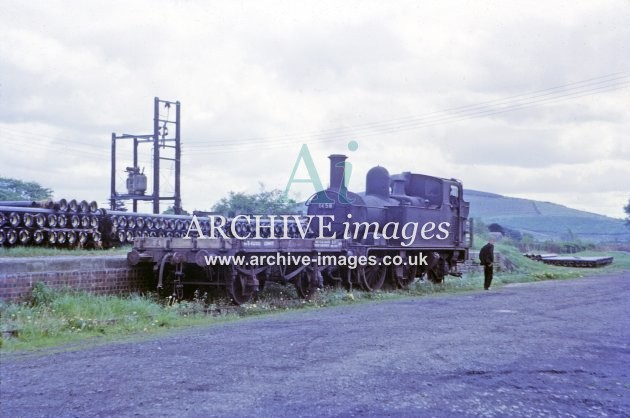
[127,155,472,304]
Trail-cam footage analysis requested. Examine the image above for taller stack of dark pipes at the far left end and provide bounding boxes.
[0,199,102,248]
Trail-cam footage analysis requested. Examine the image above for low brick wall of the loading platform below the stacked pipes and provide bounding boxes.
[0,256,153,300]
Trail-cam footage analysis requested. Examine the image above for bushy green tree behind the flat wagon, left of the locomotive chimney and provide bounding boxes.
[212,183,298,218]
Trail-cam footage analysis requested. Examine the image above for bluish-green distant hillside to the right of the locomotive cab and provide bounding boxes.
[464,190,630,243]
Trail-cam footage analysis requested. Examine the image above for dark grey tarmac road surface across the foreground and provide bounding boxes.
[0,272,630,417]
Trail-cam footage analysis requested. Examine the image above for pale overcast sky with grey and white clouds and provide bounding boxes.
[0,0,630,218]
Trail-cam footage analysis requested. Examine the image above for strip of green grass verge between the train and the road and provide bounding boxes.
[0,251,630,352]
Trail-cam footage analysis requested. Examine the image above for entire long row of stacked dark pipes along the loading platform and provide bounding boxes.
[0,199,316,248]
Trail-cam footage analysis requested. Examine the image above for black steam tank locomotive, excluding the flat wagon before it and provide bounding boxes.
[307,155,472,290]
